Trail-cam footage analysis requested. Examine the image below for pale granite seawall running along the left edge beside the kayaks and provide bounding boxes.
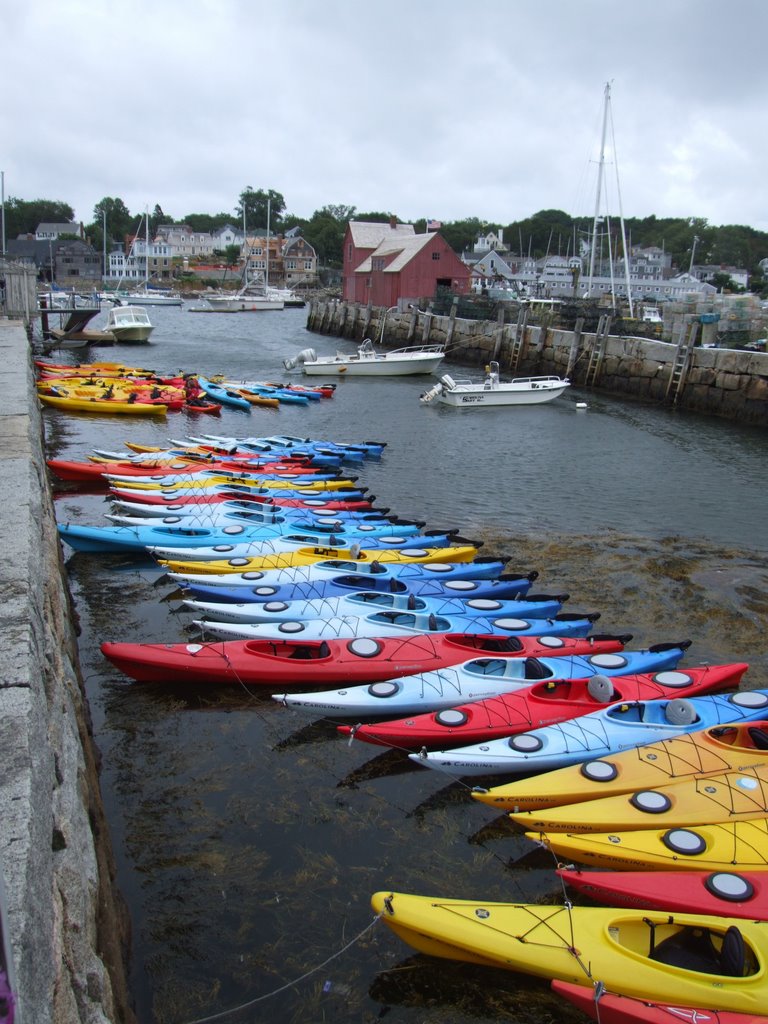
[0,319,134,1024]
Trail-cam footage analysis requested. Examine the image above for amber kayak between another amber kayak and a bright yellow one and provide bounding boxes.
[510,764,768,833]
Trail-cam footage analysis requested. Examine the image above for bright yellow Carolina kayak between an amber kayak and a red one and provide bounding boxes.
[525,818,768,872]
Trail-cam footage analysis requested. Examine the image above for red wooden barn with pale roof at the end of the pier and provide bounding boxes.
[344,220,470,306]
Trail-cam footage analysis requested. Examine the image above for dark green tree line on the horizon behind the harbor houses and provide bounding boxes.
[4,185,768,294]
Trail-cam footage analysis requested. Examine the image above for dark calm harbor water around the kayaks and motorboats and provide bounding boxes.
[44,308,768,1024]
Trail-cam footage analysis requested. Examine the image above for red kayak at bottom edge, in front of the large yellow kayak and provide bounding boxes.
[552,980,768,1024]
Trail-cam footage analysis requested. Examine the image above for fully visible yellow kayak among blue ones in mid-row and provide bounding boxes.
[159,546,479,575]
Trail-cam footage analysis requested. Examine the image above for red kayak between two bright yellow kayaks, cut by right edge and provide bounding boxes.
[557,868,768,921]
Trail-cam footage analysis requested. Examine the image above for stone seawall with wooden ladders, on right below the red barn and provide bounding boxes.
[307,301,768,426]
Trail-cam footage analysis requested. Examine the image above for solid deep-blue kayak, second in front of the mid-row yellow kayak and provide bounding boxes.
[179,563,538,602]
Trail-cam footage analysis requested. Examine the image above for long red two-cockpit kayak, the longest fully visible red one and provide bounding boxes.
[101,633,626,688]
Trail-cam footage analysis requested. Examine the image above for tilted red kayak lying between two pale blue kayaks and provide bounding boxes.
[338,662,749,750]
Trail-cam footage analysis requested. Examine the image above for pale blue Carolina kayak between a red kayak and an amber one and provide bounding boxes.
[409,689,768,775]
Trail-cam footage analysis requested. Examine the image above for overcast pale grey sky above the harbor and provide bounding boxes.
[6,0,768,230]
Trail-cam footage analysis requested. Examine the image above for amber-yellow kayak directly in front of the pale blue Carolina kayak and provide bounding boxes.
[472,721,768,811]
